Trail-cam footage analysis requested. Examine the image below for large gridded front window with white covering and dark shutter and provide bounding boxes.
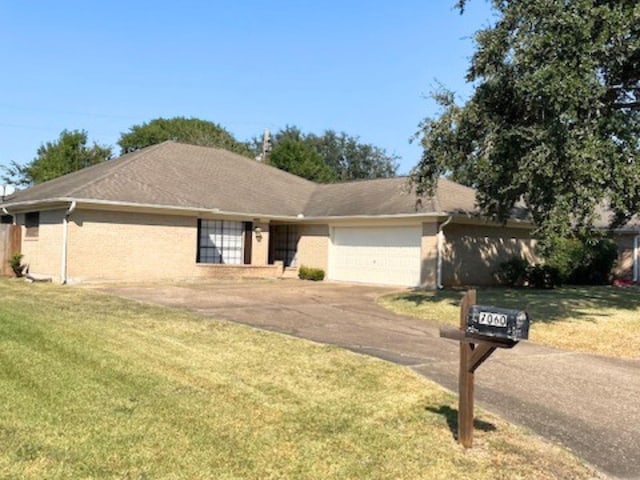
[196,220,250,265]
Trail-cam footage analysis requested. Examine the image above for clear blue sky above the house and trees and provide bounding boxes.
[0,0,491,177]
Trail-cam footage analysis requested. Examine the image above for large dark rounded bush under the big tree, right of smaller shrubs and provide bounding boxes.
[547,238,618,285]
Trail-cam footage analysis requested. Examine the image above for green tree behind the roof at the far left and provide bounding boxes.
[3,130,112,185]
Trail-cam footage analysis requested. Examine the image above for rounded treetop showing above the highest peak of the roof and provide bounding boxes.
[118,117,250,156]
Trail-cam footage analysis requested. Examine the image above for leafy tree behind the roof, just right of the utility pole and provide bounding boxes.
[262,126,398,183]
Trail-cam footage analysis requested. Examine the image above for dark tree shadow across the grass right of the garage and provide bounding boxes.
[402,286,640,323]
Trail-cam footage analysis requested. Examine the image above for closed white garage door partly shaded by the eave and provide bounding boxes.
[329,226,422,287]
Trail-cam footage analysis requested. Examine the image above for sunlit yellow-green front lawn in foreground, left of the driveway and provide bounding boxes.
[0,281,593,479]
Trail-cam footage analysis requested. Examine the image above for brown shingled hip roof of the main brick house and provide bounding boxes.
[2,141,476,218]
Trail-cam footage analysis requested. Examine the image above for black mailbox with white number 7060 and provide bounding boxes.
[466,305,529,342]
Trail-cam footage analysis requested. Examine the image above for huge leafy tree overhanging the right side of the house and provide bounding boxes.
[411,0,640,248]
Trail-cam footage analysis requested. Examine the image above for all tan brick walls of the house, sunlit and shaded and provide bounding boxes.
[10,205,552,288]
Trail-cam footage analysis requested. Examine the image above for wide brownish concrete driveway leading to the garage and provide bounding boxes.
[99,280,640,479]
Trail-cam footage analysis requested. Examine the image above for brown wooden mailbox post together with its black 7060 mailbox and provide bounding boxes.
[440,290,529,448]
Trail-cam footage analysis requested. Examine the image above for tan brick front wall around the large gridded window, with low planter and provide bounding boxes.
[68,210,280,282]
